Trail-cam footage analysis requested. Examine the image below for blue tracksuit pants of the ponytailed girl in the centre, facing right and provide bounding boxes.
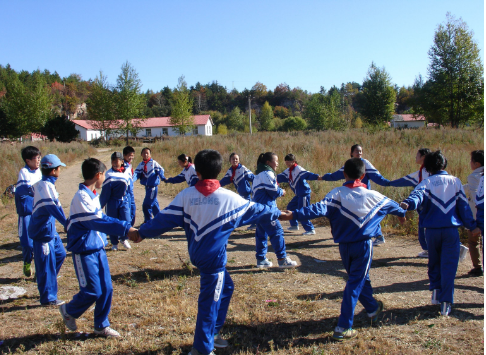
[255,221,287,260]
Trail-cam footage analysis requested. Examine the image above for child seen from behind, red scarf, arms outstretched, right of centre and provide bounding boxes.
[280,158,405,341]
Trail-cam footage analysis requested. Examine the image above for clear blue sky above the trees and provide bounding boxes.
[0,0,484,93]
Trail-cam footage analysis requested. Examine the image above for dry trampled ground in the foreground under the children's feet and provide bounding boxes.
[0,149,484,354]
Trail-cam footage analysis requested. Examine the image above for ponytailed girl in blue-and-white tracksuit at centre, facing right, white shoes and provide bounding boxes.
[252,152,297,269]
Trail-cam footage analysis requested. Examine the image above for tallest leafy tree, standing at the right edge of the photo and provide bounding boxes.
[414,13,484,128]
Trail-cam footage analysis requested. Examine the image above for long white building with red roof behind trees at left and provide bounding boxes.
[73,115,214,141]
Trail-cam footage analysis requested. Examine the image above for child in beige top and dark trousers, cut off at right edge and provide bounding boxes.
[464,150,484,276]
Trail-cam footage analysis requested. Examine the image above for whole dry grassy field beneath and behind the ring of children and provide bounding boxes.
[0,130,484,355]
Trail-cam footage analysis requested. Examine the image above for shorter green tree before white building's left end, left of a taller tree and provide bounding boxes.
[87,71,115,139]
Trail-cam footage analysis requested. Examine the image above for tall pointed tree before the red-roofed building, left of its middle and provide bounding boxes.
[114,62,145,144]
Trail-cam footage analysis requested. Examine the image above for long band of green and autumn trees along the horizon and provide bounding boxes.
[0,14,484,140]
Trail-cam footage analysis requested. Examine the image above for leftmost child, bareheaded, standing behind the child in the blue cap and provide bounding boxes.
[15,145,42,277]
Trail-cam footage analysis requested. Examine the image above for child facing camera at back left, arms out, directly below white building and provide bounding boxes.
[133,148,165,223]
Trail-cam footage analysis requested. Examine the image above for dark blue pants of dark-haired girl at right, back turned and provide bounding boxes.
[425,227,460,303]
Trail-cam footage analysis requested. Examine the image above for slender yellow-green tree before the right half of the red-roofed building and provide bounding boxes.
[170,75,194,135]
